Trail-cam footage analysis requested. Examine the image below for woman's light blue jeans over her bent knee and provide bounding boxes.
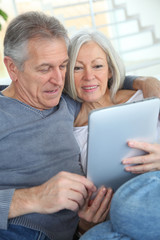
[80,171,160,240]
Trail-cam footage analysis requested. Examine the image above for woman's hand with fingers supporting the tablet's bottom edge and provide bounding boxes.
[78,187,113,233]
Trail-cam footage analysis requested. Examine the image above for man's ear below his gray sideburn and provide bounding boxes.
[4,56,18,82]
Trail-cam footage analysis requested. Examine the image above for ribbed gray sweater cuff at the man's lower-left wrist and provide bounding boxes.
[0,189,15,229]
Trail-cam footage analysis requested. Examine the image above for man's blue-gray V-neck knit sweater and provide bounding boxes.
[0,93,83,240]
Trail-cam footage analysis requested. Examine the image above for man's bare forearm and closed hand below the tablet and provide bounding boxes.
[9,172,96,218]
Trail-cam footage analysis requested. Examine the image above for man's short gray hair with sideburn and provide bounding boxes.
[4,11,69,70]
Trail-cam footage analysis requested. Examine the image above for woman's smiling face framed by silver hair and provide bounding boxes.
[74,41,111,102]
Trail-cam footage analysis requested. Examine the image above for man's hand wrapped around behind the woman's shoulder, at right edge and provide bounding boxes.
[133,77,160,98]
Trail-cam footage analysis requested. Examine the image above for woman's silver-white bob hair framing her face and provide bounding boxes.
[65,31,125,101]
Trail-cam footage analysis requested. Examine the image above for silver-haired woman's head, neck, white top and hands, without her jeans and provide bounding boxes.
[65,31,160,236]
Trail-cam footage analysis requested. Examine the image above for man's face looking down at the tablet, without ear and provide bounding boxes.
[15,39,68,110]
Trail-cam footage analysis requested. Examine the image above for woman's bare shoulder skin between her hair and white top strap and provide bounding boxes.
[115,90,136,104]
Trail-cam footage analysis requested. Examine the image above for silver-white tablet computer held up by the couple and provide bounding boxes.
[87,98,160,190]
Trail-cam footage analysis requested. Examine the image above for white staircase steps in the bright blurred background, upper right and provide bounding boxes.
[111,1,160,73]
